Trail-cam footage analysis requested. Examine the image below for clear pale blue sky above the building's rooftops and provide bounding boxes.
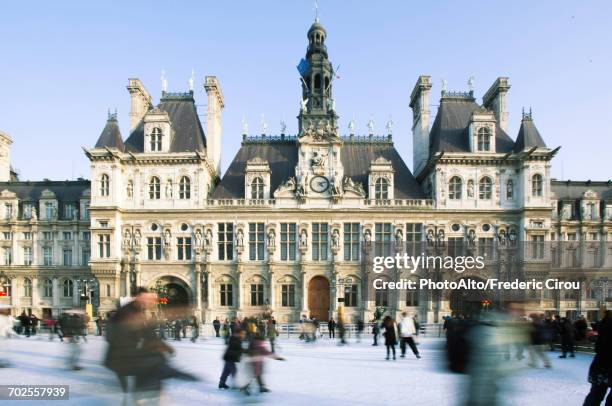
[0,0,612,180]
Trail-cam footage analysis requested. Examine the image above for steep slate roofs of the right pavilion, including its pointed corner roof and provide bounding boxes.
[429,93,514,154]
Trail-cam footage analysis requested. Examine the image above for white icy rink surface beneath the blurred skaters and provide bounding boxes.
[0,336,592,406]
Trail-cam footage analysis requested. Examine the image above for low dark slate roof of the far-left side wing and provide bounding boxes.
[0,179,91,202]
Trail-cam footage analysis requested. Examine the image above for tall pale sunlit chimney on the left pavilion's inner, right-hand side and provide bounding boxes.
[204,76,225,176]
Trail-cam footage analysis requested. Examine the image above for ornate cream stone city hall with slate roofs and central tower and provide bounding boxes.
[0,21,612,322]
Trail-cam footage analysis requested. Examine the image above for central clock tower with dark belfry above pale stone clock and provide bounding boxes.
[295,18,344,201]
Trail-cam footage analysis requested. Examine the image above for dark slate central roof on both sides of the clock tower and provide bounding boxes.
[211,137,426,199]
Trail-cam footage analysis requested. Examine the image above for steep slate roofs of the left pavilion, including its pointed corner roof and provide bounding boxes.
[125,91,206,152]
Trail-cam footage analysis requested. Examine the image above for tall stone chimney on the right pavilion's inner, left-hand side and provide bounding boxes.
[410,75,431,176]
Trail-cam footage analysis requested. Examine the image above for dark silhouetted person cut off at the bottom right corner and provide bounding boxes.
[584,310,612,406]
